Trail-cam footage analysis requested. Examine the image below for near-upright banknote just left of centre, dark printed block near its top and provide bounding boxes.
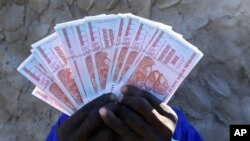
[86,15,121,93]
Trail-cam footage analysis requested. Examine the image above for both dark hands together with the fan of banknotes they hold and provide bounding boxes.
[17,13,203,141]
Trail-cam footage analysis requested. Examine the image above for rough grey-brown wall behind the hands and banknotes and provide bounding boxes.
[0,0,250,141]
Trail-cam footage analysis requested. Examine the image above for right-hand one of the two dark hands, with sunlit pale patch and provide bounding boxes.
[99,86,177,141]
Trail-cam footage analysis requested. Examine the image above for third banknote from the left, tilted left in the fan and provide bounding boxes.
[32,33,85,108]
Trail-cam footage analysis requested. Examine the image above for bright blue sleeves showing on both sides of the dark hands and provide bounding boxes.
[46,109,203,141]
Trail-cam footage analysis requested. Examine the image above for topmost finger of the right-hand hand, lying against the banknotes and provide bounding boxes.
[121,85,177,122]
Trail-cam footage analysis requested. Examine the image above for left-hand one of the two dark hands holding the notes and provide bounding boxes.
[57,94,117,141]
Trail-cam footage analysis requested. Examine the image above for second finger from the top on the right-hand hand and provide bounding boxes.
[121,96,172,135]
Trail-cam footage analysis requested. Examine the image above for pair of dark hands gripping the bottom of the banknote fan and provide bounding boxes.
[58,86,177,141]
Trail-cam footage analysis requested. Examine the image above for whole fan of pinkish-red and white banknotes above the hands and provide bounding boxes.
[18,14,203,115]
